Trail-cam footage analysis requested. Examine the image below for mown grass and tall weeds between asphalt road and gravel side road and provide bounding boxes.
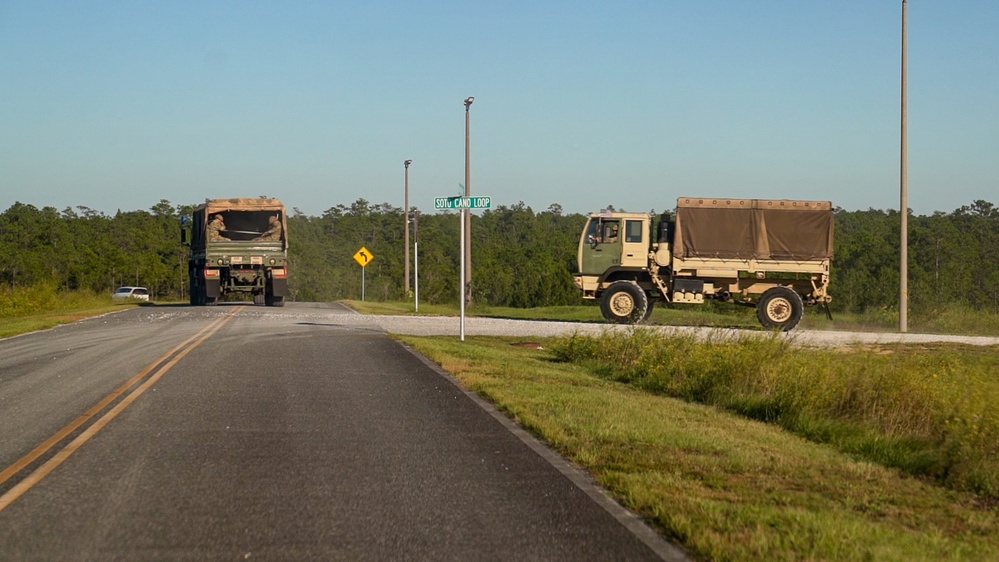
[399,330,999,560]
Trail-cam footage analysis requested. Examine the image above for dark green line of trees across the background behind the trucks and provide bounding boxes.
[0,199,999,313]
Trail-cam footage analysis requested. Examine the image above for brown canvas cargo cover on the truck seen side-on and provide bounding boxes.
[673,197,833,261]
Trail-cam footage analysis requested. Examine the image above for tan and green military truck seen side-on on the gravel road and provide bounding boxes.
[574,197,833,331]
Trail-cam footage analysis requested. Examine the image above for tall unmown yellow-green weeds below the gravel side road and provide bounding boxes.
[552,330,999,496]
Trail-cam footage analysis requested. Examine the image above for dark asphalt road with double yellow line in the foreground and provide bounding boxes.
[0,303,682,560]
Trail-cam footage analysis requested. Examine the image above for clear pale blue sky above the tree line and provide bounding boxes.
[0,0,999,215]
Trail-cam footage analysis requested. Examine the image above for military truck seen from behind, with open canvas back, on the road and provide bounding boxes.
[181,197,288,306]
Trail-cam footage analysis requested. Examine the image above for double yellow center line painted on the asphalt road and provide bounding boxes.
[0,308,240,511]
